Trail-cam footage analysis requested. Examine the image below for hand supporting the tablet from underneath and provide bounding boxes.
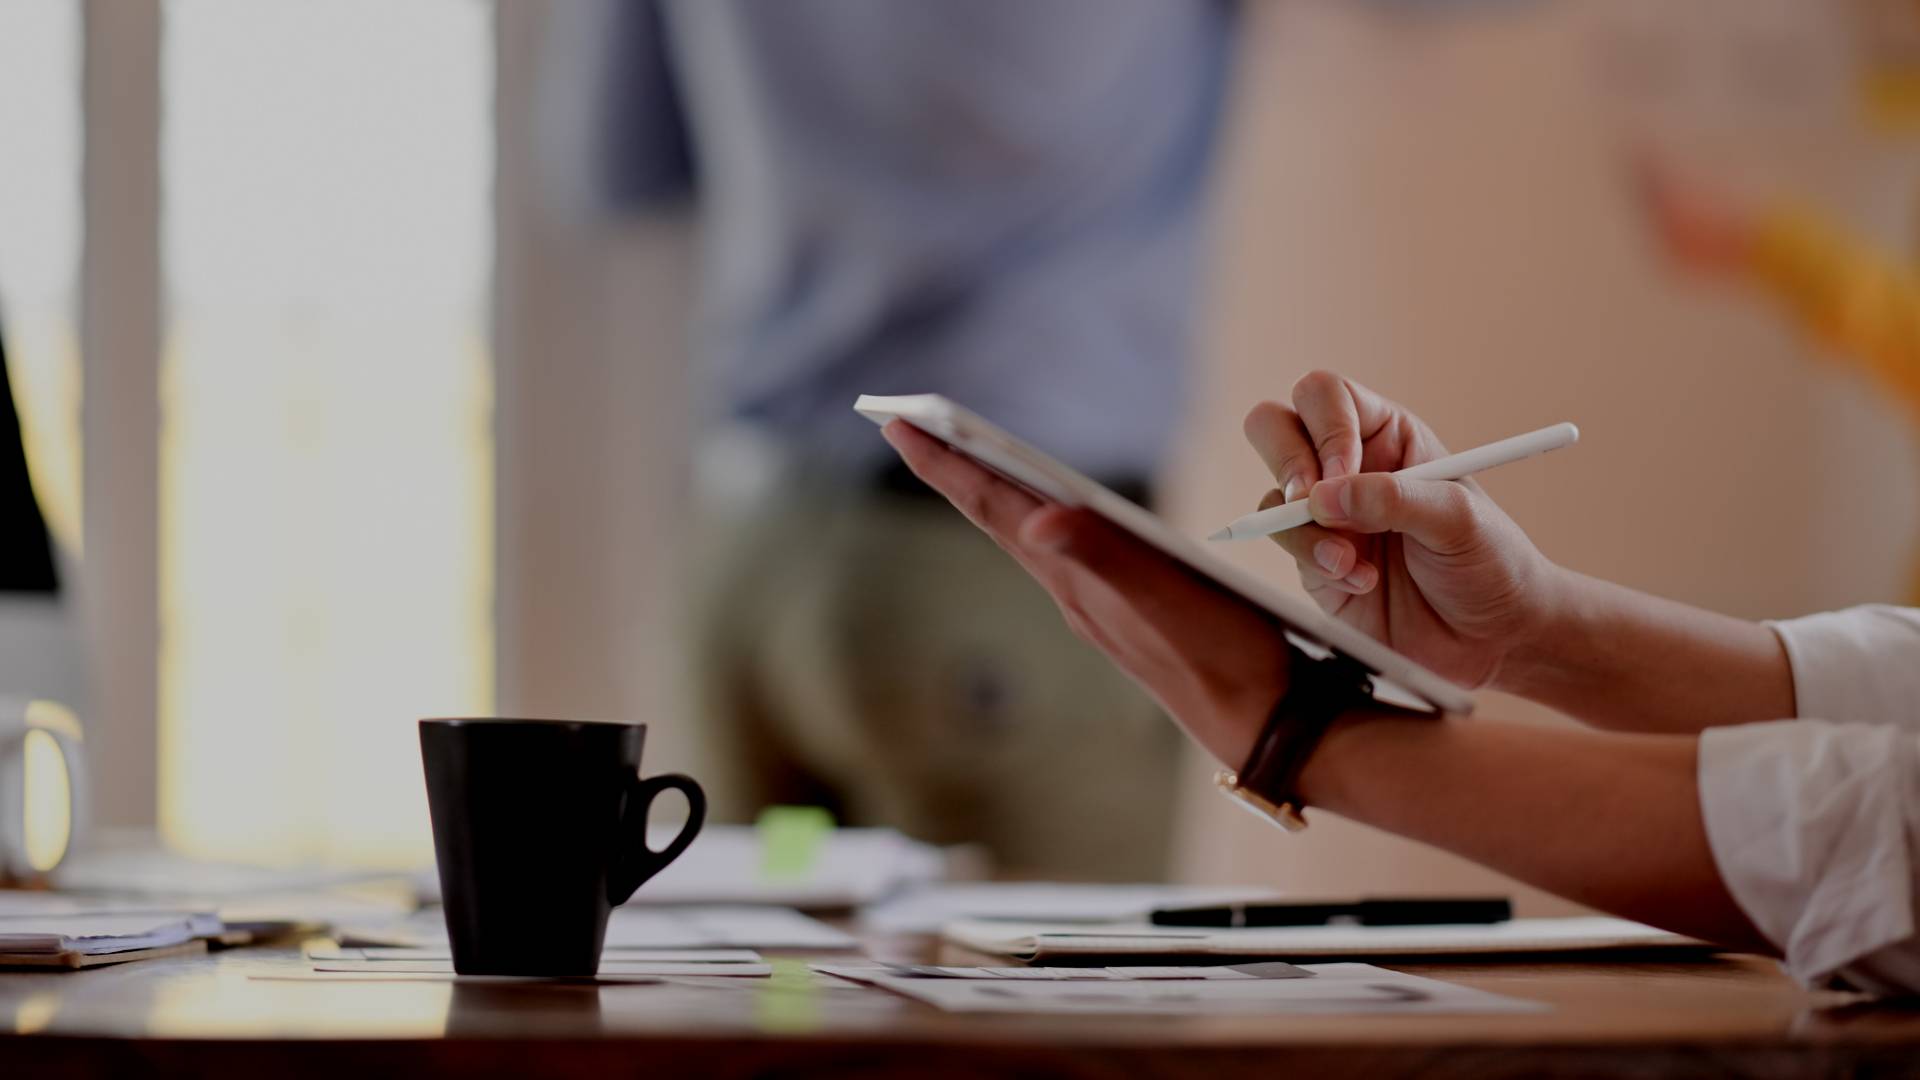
[885,421,1288,769]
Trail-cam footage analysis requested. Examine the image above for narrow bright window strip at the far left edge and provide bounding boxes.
[0,0,81,552]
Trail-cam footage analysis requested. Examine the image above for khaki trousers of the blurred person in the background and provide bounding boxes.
[689,474,1181,880]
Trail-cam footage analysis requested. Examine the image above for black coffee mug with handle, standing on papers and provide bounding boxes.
[420,717,707,976]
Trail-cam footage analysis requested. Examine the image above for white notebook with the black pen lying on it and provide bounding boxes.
[945,917,1705,959]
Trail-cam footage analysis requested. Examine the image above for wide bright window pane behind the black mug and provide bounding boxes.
[159,0,493,865]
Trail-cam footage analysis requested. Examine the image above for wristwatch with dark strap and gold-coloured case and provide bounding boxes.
[1213,650,1373,832]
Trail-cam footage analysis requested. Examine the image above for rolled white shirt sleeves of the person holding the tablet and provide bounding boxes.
[1699,607,1920,994]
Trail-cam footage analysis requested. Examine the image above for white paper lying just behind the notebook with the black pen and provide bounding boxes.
[860,882,1279,934]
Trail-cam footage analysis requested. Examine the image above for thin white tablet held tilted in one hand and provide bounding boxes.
[852,394,1473,713]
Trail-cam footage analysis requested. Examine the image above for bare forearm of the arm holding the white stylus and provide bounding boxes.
[1496,571,1795,734]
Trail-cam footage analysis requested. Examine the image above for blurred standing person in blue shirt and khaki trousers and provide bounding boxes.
[549,0,1236,878]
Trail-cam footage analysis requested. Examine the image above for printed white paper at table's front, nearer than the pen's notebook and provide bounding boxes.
[848,963,1546,1017]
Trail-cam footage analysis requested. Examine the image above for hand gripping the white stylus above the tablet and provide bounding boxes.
[1246,371,1557,686]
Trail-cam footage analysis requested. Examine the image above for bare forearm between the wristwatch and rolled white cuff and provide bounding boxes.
[1300,713,1772,951]
